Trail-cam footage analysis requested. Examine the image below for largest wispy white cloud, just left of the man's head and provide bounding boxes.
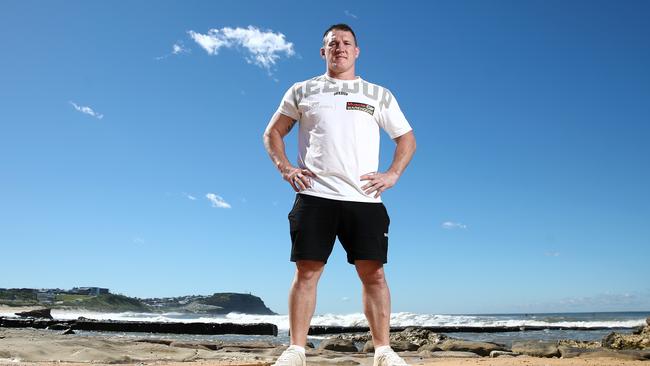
[188,25,295,73]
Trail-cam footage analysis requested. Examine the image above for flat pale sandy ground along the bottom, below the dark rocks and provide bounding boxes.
[0,328,648,366]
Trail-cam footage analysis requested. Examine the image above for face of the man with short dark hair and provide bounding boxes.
[320,29,359,73]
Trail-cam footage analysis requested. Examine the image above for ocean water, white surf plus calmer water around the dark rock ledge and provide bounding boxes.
[0,308,650,346]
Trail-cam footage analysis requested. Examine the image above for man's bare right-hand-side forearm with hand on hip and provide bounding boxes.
[361,130,416,198]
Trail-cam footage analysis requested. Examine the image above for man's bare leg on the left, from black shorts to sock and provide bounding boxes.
[289,260,325,347]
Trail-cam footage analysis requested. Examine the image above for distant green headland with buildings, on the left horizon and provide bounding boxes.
[0,288,275,315]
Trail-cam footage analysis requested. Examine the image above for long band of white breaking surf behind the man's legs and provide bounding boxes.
[0,309,645,331]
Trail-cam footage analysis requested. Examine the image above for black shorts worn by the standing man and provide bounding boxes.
[289,194,390,264]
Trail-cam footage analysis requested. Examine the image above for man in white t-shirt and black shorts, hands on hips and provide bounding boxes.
[264,24,415,366]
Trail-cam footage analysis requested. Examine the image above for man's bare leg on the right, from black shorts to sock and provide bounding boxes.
[354,260,390,349]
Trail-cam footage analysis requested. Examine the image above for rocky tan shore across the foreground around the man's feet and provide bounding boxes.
[0,310,650,366]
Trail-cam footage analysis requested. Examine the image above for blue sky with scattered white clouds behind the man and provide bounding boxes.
[0,0,650,314]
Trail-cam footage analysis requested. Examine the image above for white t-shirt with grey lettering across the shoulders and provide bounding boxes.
[278,74,411,202]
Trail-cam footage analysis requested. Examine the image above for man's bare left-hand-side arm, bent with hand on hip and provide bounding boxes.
[263,112,315,192]
